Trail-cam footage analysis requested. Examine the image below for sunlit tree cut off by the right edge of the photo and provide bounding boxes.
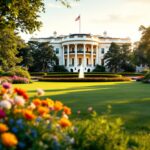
[134,26,150,67]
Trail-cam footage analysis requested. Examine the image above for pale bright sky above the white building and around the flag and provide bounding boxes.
[21,0,150,42]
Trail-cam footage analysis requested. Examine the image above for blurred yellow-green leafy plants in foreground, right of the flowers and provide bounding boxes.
[72,116,128,150]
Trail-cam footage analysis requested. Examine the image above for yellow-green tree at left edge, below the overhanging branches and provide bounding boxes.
[0,28,24,71]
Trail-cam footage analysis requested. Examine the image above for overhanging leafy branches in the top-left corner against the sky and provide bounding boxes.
[0,0,44,33]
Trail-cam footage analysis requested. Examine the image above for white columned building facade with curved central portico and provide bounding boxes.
[30,33,131,72]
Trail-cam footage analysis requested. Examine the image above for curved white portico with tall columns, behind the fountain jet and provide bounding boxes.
[63,42,99,72]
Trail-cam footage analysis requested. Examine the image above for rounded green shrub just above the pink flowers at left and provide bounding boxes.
[8,66,30,79]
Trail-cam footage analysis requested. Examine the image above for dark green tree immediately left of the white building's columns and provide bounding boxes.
[19,42,58,72]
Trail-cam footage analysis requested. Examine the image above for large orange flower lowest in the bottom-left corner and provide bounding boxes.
[1,132,18,147]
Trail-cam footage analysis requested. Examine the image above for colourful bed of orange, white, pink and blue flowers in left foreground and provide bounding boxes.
[0,82,72,149]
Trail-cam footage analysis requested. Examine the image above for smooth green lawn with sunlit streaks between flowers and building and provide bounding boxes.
[15,82,150,130]
